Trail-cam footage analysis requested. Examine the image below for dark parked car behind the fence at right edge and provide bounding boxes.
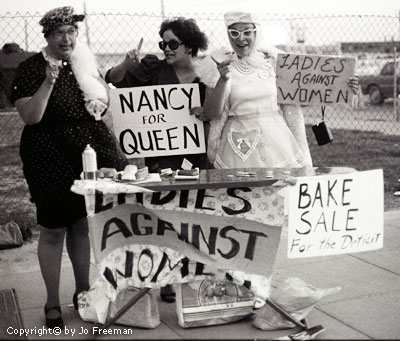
[359,61,400,104]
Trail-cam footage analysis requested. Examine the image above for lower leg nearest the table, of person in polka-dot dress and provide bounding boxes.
[67,218,90,293]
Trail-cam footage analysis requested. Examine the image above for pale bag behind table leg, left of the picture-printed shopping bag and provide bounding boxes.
[107,287,161,329]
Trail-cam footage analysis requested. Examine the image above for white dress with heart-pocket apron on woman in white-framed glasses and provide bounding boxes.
[208,54,311,168]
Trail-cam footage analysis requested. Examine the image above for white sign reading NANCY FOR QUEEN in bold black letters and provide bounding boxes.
[110,84,206,158]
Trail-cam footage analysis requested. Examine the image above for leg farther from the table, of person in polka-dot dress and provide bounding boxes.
[38,226,65,318]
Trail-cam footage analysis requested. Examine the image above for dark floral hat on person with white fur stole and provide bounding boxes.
[39,6,85,34]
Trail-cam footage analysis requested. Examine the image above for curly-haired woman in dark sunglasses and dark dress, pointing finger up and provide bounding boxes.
[105,18,214,303]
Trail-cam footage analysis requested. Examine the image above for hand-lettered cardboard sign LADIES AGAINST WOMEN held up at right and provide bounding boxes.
[276,54,356,106]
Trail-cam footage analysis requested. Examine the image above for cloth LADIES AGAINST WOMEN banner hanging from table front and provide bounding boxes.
[88,186,284,288]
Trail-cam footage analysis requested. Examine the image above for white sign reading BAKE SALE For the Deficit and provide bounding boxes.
[288,170,384,258]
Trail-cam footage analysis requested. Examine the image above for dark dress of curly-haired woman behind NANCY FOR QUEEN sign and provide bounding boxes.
[105,55,214,172]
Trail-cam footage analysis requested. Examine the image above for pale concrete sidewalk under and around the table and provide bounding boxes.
[0,211,400,340]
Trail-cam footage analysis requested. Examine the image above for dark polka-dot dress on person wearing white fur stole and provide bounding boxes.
[12,53,128,228]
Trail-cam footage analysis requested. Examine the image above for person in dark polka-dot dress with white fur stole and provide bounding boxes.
[12,7,128,328]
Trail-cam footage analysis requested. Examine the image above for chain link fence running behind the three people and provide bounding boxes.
[0,13,400,228]
